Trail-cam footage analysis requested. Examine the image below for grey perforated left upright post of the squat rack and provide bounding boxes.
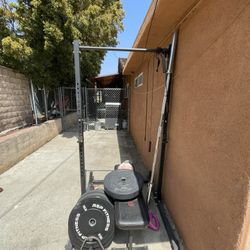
[73,40,86,194]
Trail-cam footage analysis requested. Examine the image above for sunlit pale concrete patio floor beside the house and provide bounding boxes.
[0,131,171,250]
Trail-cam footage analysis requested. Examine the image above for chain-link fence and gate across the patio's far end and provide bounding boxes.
[34,87,127,130]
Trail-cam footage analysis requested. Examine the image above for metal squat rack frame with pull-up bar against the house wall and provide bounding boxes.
[73,31,178,249]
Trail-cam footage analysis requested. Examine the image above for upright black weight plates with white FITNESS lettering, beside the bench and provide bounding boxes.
[68,190,115,250]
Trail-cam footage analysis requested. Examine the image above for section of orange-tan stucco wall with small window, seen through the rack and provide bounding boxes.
[130,56,164,173]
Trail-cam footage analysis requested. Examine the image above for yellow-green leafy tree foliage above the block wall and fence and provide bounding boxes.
[0,0,123,87]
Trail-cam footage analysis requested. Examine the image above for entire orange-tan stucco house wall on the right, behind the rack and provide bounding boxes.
[127,0,250,250]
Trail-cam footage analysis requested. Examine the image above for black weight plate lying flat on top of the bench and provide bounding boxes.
[104,169,143,201]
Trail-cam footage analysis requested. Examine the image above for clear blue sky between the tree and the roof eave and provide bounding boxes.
[100,0,152,75]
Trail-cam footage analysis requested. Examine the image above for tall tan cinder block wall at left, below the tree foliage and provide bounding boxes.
[0,66,32,132]
